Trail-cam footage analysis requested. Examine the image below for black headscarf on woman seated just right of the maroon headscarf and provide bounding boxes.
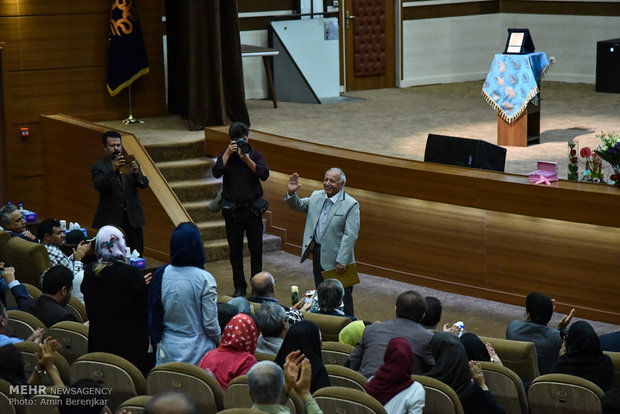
[425,332,474,400]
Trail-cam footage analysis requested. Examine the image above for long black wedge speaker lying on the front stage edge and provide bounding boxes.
[424,134,506,172]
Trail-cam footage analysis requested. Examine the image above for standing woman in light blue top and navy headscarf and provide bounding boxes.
[149,223,220,365]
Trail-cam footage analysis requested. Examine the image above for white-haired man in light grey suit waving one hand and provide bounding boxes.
[284,168,360,316]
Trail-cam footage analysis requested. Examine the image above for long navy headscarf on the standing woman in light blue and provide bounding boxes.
[149,222,205,346]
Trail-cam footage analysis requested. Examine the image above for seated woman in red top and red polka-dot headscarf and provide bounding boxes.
[198,313,258,391]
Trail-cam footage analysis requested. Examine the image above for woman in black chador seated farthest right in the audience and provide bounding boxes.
[551,321,614,391]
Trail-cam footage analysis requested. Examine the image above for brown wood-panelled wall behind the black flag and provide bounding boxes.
[0,0,167,204]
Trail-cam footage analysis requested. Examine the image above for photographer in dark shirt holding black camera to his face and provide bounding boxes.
[212,122,269,297]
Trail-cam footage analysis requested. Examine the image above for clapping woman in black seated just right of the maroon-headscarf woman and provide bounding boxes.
[425,332,505,414]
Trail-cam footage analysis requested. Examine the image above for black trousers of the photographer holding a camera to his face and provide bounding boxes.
[222,208,263,290]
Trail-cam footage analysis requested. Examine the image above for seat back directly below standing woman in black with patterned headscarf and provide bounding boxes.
[70,352,146,411]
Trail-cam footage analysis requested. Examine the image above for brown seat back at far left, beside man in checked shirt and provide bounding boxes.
[7,237,50,286]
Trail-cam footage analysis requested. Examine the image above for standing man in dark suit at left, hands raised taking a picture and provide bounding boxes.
[90,131,149,256]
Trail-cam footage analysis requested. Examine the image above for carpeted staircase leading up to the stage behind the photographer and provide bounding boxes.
[145,140,281,261]
